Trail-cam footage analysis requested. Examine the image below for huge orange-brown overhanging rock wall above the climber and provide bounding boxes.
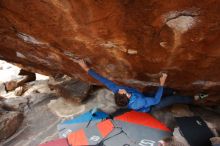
[0,0,220,96]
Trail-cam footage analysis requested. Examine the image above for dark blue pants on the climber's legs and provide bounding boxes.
[145,88,193,110]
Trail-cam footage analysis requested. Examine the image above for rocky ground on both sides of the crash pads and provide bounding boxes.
[0,60,220,146]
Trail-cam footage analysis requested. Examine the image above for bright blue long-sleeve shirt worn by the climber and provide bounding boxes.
[88,69,163,112]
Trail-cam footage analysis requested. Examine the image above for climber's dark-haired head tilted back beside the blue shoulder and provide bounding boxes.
[115,89,131,107]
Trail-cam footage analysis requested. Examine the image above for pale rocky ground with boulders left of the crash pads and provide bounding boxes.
[0,61,116,146]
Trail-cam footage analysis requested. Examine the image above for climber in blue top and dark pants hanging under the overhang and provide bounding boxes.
[73,59,204,112]
